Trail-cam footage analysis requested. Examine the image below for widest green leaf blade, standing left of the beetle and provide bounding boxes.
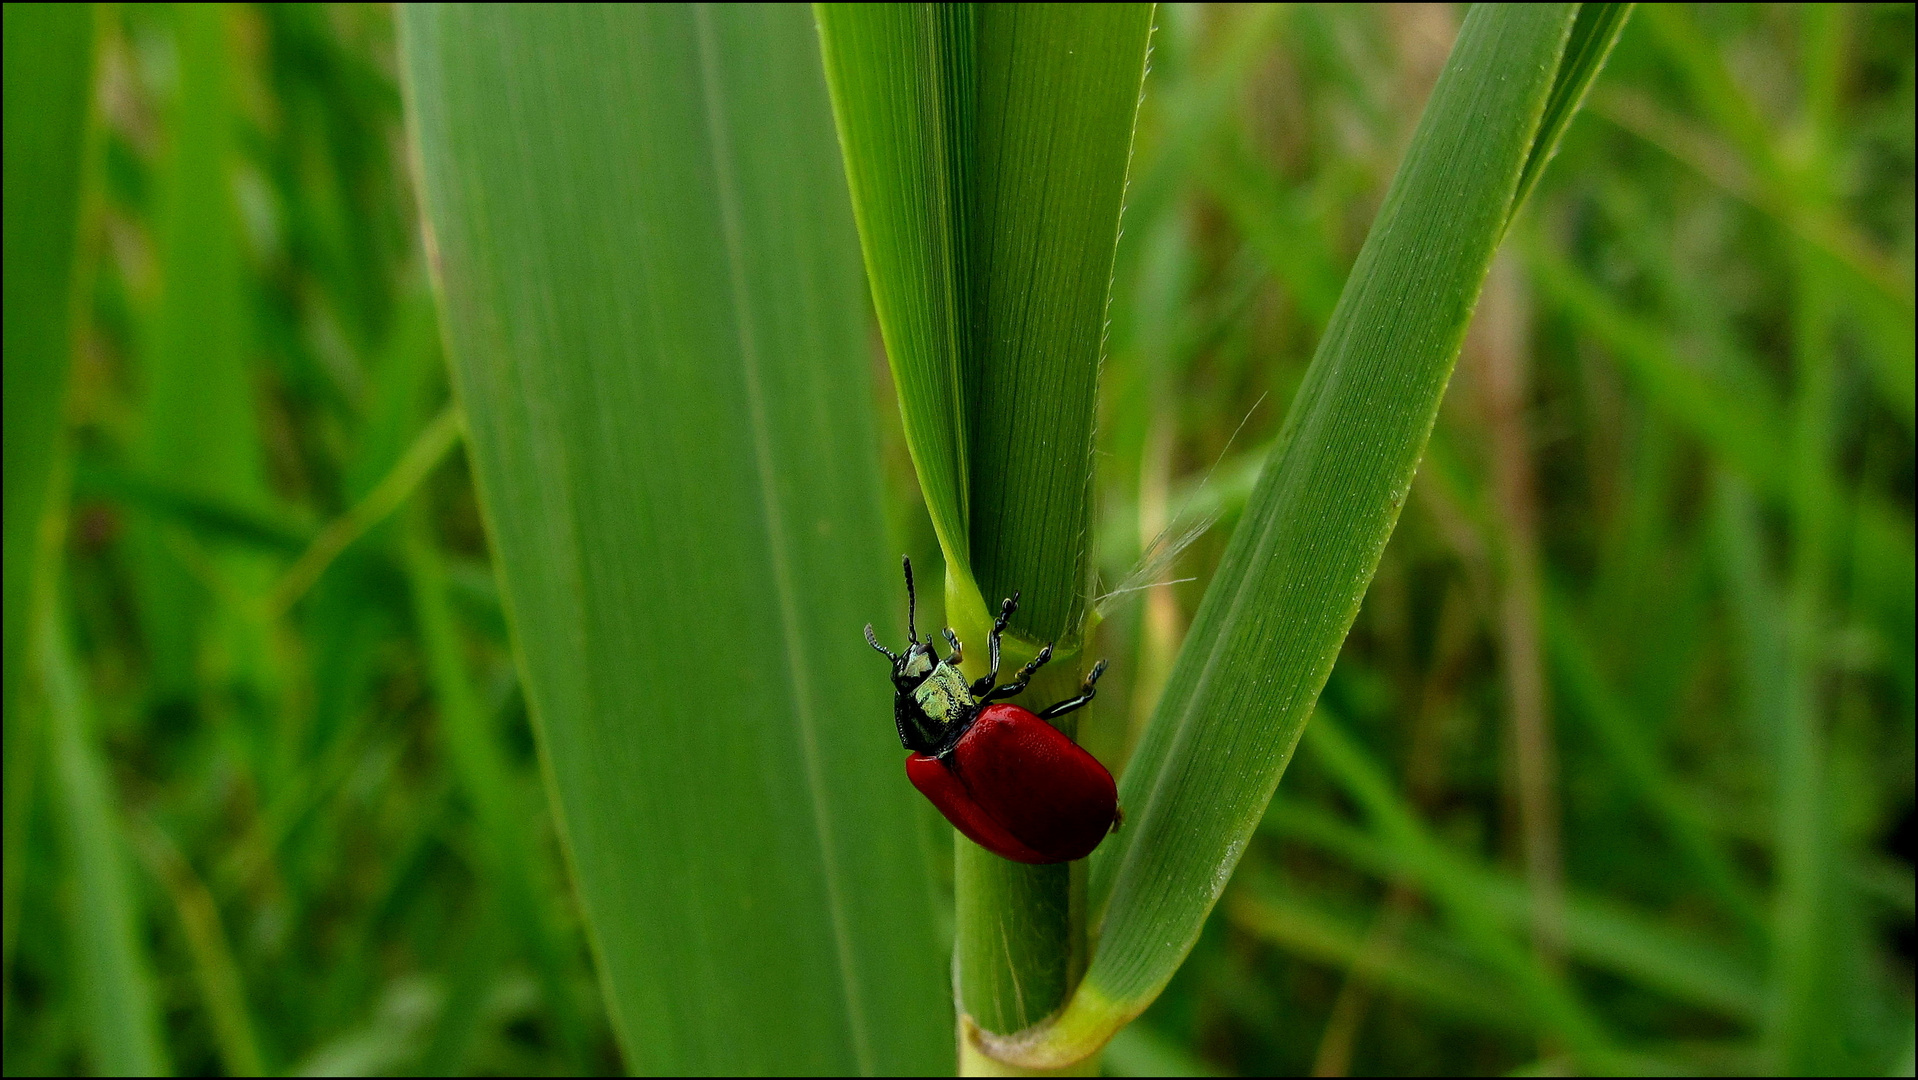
[401,6,951,1072]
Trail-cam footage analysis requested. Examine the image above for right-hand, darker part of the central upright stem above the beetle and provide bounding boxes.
[967,4,1153,656]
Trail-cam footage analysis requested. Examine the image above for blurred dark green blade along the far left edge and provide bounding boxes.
[0,4,94,997]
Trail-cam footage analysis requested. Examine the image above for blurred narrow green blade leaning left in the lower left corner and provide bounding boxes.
[35,602,169,1076]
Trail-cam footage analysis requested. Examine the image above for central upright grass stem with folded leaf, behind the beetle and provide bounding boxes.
[817,4,1153,1032]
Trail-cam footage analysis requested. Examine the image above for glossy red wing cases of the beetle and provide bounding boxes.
[905,704,1118,863]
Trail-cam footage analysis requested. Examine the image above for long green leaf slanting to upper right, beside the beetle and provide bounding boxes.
[994,6,1598,1067]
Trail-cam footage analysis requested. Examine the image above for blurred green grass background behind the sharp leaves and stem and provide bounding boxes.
[6,4,1914,1074]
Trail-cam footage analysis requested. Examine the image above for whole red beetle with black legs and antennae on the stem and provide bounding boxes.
[865,558,1120,863]
